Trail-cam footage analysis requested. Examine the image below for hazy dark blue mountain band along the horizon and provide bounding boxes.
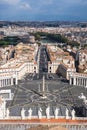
[0,21,87,27]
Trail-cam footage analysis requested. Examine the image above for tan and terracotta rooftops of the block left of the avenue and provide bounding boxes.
[0,43,38,69]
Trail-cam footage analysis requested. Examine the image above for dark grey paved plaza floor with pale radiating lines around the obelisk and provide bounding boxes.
[0,73,87,117]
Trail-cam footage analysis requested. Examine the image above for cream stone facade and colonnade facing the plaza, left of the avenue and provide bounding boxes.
[0,62,38,87]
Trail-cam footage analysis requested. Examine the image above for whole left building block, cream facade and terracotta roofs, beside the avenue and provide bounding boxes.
[0,43,39,87]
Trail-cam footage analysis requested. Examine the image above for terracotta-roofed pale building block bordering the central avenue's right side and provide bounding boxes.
[47,45,69,73]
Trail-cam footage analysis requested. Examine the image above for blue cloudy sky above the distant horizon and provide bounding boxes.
[0,0,87,21]
